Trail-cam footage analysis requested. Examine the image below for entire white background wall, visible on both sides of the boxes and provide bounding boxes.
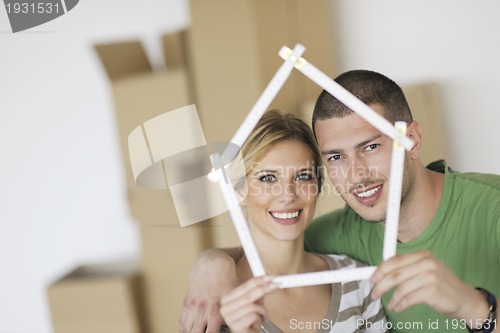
[0,0,500,333]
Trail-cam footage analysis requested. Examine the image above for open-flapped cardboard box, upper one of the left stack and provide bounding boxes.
[95,37,192,225]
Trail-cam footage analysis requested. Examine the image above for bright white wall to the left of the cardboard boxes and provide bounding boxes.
[0,0,188,333]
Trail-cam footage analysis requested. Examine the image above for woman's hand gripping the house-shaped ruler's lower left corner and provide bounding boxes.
[220,276,278,333]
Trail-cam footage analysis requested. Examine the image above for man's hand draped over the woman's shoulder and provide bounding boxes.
[179,248,243,333]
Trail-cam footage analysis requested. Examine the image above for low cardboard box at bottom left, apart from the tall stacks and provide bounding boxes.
[48,263,147,333]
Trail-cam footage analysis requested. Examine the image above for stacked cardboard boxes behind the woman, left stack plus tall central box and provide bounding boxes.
[49,0,446,333]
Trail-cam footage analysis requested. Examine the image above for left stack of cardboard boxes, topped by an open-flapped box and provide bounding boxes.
[95,33,211,333]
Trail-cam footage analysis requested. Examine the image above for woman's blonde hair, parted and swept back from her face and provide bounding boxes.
[241,110,323,189]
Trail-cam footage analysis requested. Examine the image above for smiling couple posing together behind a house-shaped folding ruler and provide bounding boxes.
[180,70,500,333]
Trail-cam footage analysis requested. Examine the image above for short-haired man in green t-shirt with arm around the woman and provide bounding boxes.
[181,70,500,332]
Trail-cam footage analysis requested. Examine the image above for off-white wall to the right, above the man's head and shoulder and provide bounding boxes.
[334,0,500,173]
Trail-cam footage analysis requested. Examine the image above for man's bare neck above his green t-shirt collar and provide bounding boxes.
[398,165,444,243]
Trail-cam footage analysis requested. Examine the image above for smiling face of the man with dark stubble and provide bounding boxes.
[315,105,409,222]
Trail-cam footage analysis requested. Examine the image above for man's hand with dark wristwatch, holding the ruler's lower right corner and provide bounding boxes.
[371,251,488,323]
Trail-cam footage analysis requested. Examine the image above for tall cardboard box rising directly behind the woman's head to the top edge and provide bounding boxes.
[187,0,335,247]
